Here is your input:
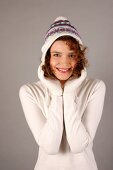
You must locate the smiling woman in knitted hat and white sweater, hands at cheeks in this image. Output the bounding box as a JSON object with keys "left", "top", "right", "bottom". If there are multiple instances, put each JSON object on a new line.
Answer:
{"left": 19, "top": 17, "right": 105, "bottom": 170}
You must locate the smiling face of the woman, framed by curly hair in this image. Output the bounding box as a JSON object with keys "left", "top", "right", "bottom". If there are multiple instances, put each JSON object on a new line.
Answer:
{"left": 50, "top": 40, "right": 77, "bottom": 84}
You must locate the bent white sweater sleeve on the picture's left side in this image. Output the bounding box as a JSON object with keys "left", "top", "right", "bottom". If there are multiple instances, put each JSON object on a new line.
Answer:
{"left": 19, "top": 85, "right": 63, "bottom": 154}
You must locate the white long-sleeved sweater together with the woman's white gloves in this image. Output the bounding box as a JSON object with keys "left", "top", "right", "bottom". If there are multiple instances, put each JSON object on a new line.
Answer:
{"left": 19, "top": 67, "right": 105, "bottom": 170}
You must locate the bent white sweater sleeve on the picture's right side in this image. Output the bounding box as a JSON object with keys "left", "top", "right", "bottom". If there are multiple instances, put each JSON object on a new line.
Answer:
{"left": 63, "top": 81, "right": 105, "bottom": 153}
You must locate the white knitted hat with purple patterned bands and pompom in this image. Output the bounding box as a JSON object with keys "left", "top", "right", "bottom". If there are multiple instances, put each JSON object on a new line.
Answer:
{"left": 41, "top": 16, "right": 83, "bottom": 64}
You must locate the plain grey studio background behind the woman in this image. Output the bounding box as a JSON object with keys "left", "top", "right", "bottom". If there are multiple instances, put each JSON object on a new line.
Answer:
{"left": 0, "top": 0, "right": 113, "bottom": 170}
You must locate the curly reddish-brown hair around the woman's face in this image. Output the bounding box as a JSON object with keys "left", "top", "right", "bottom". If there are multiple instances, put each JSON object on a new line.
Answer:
{"left": 42, "top": 36, "right": 89, "bottom": 79}
